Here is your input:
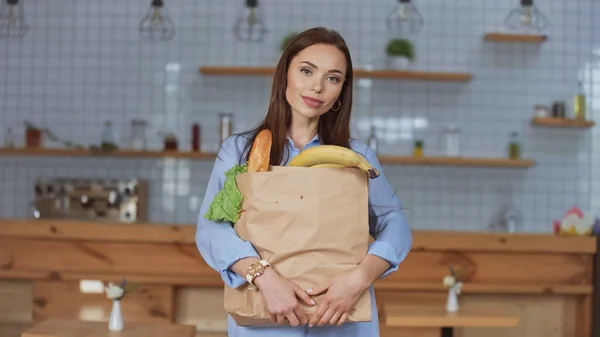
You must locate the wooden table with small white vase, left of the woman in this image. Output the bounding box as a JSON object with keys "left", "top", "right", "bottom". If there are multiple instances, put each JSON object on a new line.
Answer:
{"left": 21, "top": 319, "right": 196, "bottom": 337}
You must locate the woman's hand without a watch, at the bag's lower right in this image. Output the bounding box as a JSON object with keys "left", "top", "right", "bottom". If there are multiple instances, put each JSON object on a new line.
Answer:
{"left": 307, "top": 268, "right": 370, "bottom": 327}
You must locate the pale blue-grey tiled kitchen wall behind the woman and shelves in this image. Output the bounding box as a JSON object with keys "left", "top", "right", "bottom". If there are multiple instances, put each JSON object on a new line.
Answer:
{"left": 0, "top": 0, "right": 600, "bottom": 232}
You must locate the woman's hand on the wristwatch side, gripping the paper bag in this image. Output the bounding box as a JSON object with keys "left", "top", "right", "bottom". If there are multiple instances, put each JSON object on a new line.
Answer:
{"left": 254, "top": 268, "right": 315, "bottom": 326}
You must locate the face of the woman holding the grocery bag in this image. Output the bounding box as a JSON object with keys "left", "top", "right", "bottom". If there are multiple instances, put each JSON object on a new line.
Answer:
{"left": 285, "top": 44, "right": 346, "bottom": 119}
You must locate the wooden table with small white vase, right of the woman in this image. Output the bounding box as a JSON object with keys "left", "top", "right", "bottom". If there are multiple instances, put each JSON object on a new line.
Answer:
{"left": 384, "top": 305, "right": 519, "bottom": 337}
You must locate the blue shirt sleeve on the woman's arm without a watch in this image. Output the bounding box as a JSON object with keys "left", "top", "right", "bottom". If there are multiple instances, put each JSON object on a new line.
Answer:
{"left": 365, "top": 147, "right": 412, "bottom": 278}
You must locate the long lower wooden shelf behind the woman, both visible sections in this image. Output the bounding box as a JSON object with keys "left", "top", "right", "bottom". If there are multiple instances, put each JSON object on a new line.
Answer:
{"left": 0, "top": 148, "right": 535, "bottom": 168}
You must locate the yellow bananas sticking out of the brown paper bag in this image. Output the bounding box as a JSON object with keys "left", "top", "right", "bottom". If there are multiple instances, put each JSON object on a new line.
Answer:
{"left": 289, "top": 145, "right": 379, "bottom": 179}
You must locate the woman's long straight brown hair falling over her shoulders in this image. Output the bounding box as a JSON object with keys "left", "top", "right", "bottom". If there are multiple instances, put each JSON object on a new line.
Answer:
{"left": 240, "top": 27, "right": 354, "bottom": 165}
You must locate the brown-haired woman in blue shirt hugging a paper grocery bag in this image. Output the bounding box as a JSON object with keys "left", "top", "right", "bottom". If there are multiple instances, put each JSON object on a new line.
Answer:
{"left": 196, "top": 28, "right": 412, "bottom": 337}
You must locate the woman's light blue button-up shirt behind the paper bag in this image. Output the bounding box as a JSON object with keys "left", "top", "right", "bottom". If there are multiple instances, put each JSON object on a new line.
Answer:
{"left": 196, "top": 136, "right": 412, "bottom": 337}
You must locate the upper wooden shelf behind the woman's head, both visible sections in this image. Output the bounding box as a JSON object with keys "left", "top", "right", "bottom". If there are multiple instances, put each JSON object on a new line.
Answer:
{"left": 200, "top": 66, "right": 473, "bottom": 82}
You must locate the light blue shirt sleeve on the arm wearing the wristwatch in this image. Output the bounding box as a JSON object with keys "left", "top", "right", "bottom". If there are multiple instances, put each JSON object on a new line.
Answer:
{"left": 196, "top": 137, "right": 259, "bottom": 288}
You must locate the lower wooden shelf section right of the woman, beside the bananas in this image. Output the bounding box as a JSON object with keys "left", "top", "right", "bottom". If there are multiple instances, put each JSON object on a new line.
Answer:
{"left": 379, "top": 156, "right": 535, "bottom": 168}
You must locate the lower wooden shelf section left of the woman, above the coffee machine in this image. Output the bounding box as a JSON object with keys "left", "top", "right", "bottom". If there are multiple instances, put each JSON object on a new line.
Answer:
{"left": 0, "top": 148, "right": 216, "bottom": 159}
